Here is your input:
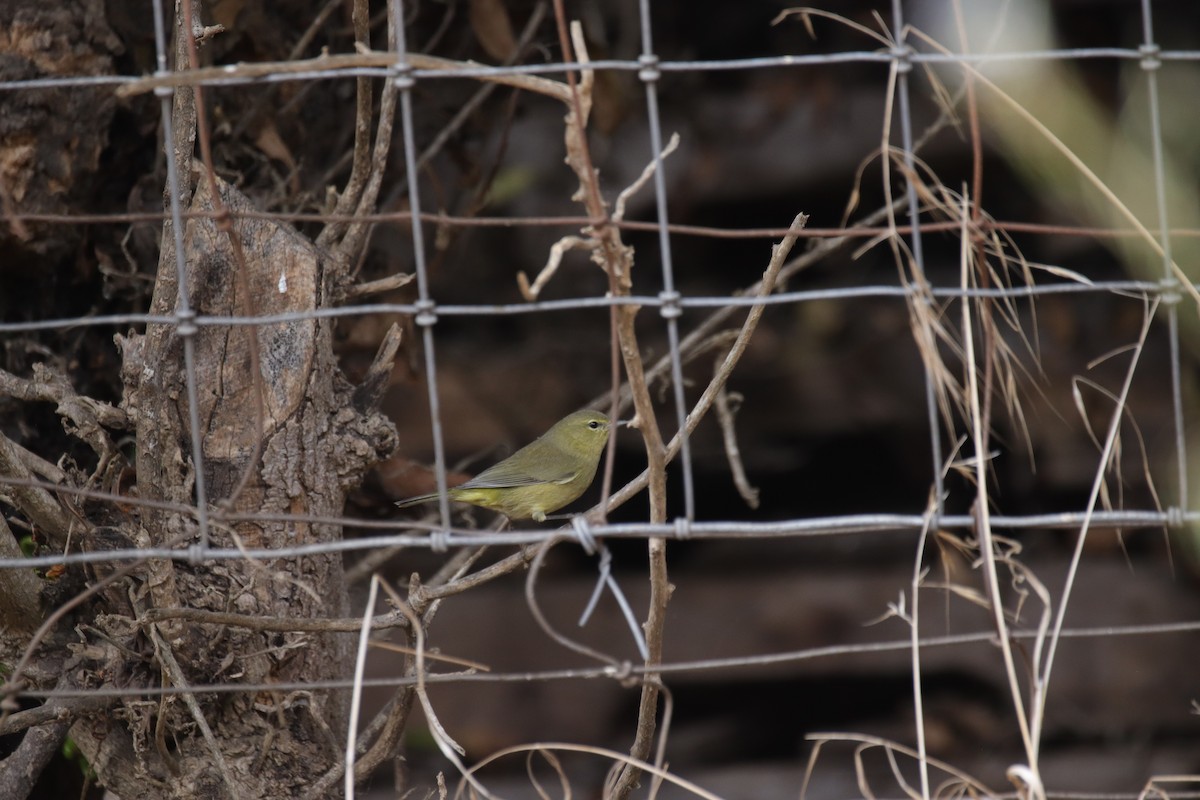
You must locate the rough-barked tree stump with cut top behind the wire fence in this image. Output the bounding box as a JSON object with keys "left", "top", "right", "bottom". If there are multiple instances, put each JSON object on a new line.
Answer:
{"left": 72, "top": 180, "right": 395, "bottom": 799}
